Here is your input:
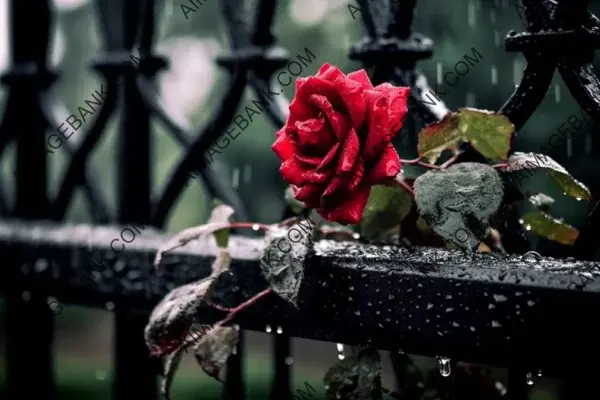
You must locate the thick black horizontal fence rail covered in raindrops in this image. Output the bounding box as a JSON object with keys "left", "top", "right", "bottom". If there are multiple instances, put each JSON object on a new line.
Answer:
{"left": 0, "top": 220, "right": 600, "bottom": 376}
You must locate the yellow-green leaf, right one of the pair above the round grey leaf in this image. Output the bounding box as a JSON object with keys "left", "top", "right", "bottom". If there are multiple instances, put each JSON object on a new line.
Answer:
{"left": 458, "top": 108, "right": 515, "bottom": 160}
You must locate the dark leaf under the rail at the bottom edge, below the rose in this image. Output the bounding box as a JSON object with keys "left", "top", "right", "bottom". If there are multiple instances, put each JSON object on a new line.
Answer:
{"left": 323, "top": 349, "right": 382, "bottom": 400}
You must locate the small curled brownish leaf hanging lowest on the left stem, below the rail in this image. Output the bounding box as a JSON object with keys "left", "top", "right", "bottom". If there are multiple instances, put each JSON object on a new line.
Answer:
{"left": 194, "top": 326, "right": 239, "bottom": 381}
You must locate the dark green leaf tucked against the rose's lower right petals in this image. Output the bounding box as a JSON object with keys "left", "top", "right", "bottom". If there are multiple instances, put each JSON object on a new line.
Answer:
{"left": 360, "top": 185, "right": 412, "bottom": 240}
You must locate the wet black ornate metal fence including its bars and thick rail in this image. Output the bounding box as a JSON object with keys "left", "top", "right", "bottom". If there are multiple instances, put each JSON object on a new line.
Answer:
{"left": 0, "top": 0, "right": 600, "bottom": 400}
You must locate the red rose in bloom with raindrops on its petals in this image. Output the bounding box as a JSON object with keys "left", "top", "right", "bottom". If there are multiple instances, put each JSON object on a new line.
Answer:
{"left": 272, "top": 63, "right": 410, "bottom": 224}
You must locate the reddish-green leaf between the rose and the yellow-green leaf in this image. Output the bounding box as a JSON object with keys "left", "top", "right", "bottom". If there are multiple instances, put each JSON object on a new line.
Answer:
{"left": 417, "top": 112, "right": 460, "bottom": 164}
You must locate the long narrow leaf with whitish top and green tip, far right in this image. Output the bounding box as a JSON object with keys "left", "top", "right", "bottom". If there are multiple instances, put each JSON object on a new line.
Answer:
{"left": 503, "top": 152, "right": 592, "bottom": 200}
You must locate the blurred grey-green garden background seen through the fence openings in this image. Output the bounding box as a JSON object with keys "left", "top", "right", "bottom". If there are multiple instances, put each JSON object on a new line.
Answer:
{"left": 0, "top": 0, "right": 600, "bottom": 400}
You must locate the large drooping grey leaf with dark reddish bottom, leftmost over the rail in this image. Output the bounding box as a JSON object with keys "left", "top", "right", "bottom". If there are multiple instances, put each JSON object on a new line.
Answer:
{"left": 144, "top": 251, "right": 231, "bottom": 355}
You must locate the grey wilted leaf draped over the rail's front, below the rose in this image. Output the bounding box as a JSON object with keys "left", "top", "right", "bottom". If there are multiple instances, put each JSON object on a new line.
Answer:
{"left": 260, "top": 218, "right": 312, "bottom": 306}
